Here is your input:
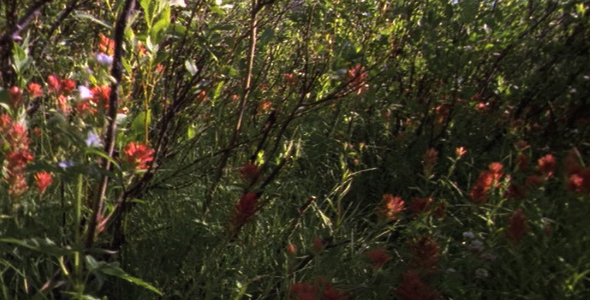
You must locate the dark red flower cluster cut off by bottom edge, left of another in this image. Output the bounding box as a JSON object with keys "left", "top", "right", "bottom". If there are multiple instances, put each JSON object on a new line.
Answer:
{"left": 289, "top": 278, "right": 348, "bottom": 300}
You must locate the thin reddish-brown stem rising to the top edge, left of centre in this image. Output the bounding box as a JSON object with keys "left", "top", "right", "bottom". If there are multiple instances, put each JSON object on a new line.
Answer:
{"left": 203, "top": 0, "right": 259, "bottom": 213}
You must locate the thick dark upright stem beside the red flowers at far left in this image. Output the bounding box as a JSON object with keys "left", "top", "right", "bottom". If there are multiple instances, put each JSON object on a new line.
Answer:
{"left": 85, "top": 0, "right": 135, "bottom": 248}
